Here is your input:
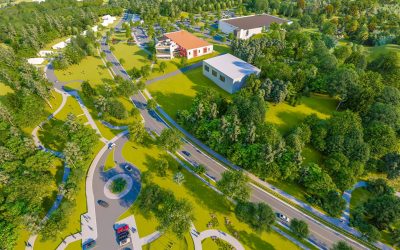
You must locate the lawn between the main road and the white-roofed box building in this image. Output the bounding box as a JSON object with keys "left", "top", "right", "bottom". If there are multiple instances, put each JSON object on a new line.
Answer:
{"left": 147, "top": 67, "right": 229, "bottom": 118}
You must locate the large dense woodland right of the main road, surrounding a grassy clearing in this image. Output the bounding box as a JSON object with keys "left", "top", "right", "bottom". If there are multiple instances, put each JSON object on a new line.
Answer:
{"left": 177, "top": 26, "right": 400, "bottom": 242}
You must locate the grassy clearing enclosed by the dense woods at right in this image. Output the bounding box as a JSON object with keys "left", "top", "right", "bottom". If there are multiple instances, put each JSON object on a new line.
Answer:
{"left": 265, "top": 94, "right": 337, "bottom": 133}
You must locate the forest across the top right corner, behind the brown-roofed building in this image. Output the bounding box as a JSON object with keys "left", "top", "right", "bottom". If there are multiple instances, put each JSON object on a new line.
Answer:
{"left": 243, "top": 0, "right": 400, "bottom": 45}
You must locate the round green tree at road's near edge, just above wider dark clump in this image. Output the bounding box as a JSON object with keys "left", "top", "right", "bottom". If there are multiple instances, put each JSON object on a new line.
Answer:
{"left": 217, "top": 170, "right": 250, "bottom": 201}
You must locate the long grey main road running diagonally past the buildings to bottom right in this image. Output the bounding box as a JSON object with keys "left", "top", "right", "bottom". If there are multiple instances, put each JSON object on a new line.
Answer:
{"left": 101, "top": 38, "right": 374, "bottom": 249}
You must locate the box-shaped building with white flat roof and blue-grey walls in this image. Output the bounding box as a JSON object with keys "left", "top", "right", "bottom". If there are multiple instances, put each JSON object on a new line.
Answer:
{"left": 203, "top": 54, "right": 261, "bottom": 94}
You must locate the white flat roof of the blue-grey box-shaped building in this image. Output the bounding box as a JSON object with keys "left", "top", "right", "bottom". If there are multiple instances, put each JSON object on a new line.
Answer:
{"left": 204, "top": 54, "right": 261, "bottom": 79}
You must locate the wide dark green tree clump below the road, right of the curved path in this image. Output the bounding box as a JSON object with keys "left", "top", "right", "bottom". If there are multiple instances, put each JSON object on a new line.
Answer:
{"left": 235, "top": 202, "right": 276, "bottom": 231}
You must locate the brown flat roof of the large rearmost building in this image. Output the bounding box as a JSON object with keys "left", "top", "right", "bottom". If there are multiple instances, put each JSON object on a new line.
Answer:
{"left": 221, "top": 14, "right": 291, "bottom": 30}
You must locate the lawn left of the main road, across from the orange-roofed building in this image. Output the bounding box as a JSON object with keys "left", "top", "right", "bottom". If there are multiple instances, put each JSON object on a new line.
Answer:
{"left": 55, "top": 56, "right": 112, "bottom": 85}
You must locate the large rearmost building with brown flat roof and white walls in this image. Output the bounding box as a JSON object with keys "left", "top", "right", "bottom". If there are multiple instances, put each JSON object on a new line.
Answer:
{"left": 218, "top": 14, "right": 292, "bottom": 39}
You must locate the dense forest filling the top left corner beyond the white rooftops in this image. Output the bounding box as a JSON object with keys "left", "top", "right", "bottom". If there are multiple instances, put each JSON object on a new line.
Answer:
{"left": 0, "top": 0, "right": 122, "bottom": 57}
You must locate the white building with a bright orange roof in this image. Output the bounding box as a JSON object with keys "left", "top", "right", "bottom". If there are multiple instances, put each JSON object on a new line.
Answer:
{"left": 156, "top": 30, "right": 213, "bottom": 59}
